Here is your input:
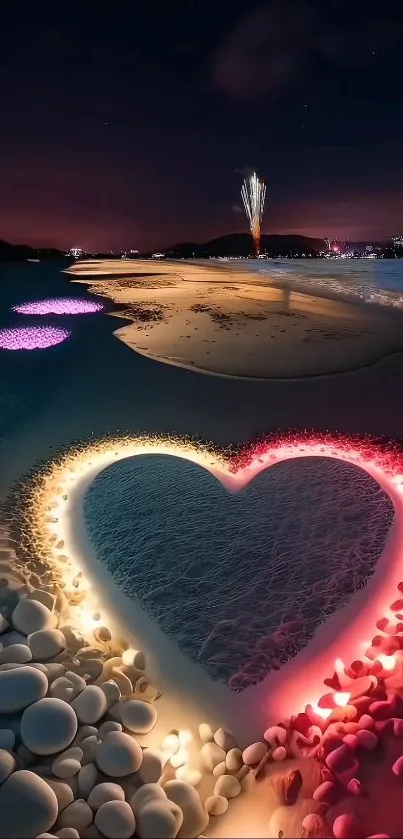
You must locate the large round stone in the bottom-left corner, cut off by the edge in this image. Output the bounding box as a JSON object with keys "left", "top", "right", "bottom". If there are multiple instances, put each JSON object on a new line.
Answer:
{"left": 0, "top": 769, "right": 58, "bottom": 839}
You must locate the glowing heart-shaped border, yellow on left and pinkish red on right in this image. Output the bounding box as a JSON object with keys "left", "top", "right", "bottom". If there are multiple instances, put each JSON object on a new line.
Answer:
{"left": 27, "top": 434, "right": 403, "bottom": 739}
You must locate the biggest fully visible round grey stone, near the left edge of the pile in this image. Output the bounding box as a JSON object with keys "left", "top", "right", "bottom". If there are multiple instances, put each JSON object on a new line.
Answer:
{"left": 21, "top": 700, "right": 77, "bottom": 755}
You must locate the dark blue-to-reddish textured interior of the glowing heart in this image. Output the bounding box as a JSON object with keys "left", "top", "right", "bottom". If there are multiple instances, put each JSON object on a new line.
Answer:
{"left": 84, "top": 449, "right": 393, "bottom": 691}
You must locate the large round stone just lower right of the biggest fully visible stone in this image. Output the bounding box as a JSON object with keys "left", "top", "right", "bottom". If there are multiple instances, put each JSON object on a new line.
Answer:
{"left": 95, "top": 731, "right": 143, "bottom": 778}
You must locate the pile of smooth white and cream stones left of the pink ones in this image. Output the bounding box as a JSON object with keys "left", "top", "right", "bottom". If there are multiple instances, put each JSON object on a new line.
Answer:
{"left": 0, "top": 585, "right": 248, "bottom": 839}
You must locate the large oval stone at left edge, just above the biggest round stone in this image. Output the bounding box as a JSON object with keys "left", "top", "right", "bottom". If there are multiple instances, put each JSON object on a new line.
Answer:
{"left": 0, "top": 666, "right": 48, "bottom": 714}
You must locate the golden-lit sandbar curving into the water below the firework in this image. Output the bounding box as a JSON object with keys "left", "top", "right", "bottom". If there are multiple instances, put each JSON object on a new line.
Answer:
{"left": 69, "top": 260, "right": 403, "bottom": 379}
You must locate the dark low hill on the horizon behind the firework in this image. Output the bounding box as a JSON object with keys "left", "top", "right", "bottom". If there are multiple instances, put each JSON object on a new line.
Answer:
{"left": 159, "top": 233, "right": 325, "bottom": 259}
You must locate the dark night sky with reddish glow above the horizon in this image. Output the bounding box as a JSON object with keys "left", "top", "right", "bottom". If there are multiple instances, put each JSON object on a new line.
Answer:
{"left": 0, "top": 0, "right": 403, "bottom": 250}
